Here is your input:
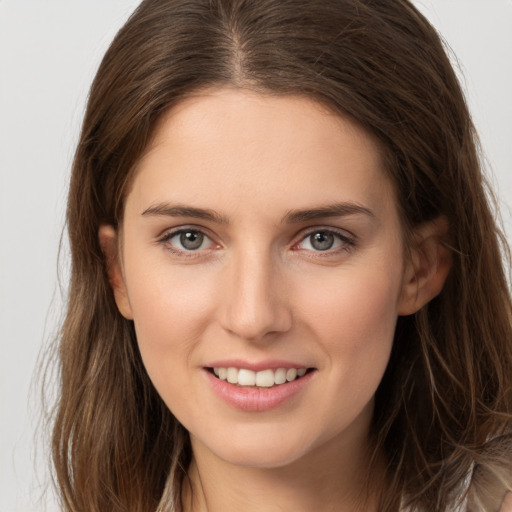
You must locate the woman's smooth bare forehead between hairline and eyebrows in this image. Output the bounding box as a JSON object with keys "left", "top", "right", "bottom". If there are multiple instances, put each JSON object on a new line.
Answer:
{"left": 128, "top": 88, "right": 394, "bottom": 222}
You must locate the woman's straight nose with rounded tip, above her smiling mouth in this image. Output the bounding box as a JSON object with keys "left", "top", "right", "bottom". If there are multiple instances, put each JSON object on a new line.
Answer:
{"left": 219, "top": 247, "right": 292, "bottom": 341}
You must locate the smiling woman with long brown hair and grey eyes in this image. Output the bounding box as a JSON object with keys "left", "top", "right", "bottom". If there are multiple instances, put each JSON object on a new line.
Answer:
{"left": 53, "top": 0, "right": 512, "bottom": 512}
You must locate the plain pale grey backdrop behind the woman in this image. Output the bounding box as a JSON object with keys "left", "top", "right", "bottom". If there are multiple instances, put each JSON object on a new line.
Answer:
{"left": 0, "top": 0, "right": 512, "bottom": 512}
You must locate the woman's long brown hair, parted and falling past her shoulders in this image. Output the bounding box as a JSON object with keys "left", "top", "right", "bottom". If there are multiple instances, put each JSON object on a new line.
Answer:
{"left": 53, "top": 0, "right": 512, "bottom": 512}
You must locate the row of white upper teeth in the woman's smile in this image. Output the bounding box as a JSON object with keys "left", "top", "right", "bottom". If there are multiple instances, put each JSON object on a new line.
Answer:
{"left": 213, "top": 367, "right": 307, "bottom": 388}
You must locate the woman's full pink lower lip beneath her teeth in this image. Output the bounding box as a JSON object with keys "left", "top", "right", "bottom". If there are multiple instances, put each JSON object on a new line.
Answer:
{"left": 204, "top": 368, "right": 316, "bottom": 412}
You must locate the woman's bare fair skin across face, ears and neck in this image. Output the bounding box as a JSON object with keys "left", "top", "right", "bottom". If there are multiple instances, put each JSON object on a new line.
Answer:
{"left": 100, "top": 88, "right": 450, "bottom": 512}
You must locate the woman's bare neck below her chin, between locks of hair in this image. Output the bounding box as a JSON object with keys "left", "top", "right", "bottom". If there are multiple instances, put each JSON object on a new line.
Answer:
{"left": 183, "top": 430, "right": 384, "bottom": 512}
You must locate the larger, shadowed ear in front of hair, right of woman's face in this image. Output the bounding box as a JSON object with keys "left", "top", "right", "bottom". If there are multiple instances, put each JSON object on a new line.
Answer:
{"left": 398, "top": 217, "right": 452, "bottom": 315}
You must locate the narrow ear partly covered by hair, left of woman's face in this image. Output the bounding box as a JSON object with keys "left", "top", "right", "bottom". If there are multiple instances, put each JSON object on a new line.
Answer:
{"left": 98, "top": 225, "right": 133, "bottom": 320}
